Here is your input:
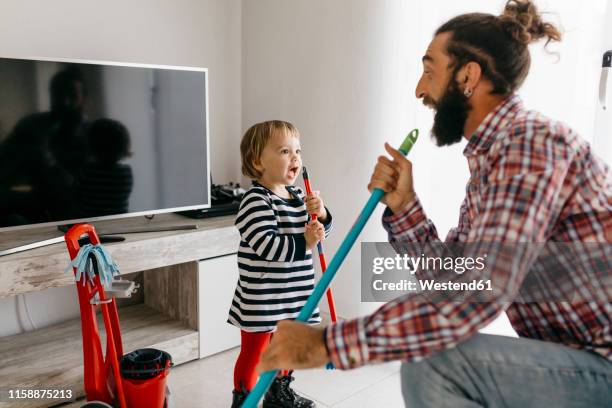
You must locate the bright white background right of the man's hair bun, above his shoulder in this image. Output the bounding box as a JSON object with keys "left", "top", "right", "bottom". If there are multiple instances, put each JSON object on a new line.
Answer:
{"left": 521, "top": 0, "right": 607, "bottom": 147}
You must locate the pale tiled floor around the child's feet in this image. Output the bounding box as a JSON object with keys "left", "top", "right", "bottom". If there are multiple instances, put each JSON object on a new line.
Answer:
{"left": 168, "top": 348, "right": 404, "bottom": 408}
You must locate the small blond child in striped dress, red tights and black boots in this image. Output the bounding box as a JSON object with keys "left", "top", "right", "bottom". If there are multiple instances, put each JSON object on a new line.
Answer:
{"left": 228, "top": 121, "right": 331, "bottom": 408}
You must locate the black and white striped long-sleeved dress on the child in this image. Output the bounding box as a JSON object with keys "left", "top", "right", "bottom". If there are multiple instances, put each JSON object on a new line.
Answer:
{"left": 228, "top": 182, "right": 331, "bottom": 332}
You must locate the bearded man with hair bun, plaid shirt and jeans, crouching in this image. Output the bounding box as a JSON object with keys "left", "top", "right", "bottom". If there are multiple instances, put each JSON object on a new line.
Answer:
{"left": 259, "top": 1, "right": 612, "bottom": 407}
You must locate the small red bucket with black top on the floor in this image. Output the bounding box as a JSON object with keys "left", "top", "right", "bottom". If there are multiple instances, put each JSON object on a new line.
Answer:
{"left": 121, "top": 349, "right": 172, "bottom": 408}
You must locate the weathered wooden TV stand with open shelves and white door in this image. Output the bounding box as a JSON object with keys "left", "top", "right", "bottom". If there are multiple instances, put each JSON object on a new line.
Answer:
{"left": 0, "top": 214, "right": 240, "bottom": 408}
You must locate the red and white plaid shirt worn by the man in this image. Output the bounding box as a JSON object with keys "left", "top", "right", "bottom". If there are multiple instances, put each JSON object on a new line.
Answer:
{"left": 324, "top": 95, "right": 612, "bottom": 369}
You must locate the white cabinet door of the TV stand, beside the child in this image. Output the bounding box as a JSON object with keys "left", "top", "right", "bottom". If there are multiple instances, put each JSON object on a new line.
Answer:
{"left": 198, "top": 255, "right": 240, "bottom": 358}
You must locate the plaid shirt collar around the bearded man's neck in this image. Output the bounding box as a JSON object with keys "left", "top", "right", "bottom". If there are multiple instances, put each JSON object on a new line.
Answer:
{"left": 463, "top": 94, "right": 523, "bottom": 157}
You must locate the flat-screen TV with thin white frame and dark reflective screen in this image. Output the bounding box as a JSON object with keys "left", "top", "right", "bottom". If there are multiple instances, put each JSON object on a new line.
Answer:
{"left": 0, "top": 58, "right": 210, "bottom": 231}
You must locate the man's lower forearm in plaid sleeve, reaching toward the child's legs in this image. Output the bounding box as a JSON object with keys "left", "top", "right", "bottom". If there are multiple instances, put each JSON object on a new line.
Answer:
{"left": 325, "top": 296, "right": 503, "bottom": 370}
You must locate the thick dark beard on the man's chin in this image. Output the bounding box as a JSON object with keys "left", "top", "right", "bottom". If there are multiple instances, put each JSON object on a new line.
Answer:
{"left": 423, "top": 79, "right": 472, "bottom": 146}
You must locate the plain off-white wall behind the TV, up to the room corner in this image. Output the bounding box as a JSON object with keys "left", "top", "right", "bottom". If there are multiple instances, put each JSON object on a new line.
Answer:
{"left": 0, "top": 0, "right": 242, "bottom": 336}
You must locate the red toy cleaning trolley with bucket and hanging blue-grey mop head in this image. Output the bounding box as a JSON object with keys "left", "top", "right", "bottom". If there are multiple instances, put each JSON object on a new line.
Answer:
{"left": 64, "top": 224, "right": 172, "bottom": 408}
